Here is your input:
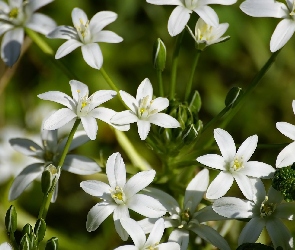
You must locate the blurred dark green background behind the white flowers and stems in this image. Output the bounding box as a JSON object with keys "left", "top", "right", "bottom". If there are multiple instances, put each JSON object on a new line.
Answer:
{"left": 0, "top": 0, "right": 295, "bottom": 249}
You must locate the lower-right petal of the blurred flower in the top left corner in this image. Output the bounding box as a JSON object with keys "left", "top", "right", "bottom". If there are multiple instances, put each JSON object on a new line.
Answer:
{"left": 26, "top": 13, "right": 56, "bottom": 35}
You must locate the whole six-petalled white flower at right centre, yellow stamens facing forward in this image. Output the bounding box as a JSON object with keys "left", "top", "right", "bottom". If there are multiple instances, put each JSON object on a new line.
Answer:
{"left": 197, "top": 128, "right": 275, "bottom": 200}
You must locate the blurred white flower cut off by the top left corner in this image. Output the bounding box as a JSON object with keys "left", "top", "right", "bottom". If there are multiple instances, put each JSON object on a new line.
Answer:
{"left": 0, "top": 0, "right": 56, "bottom": 67}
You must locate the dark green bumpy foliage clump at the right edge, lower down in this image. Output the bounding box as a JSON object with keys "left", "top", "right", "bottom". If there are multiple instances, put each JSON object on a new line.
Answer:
{"left": 272, "top": 164, "right": 295, "bottom": 202}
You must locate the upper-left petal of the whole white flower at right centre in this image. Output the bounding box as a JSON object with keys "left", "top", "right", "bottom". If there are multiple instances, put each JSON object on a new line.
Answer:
{"left": 214, "top": 128, "right": 236, "bottom": 162}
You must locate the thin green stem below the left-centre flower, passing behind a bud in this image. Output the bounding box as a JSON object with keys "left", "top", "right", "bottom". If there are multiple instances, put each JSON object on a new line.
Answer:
{"left": 38, "top": 119, "right": 81, "bottom": 220}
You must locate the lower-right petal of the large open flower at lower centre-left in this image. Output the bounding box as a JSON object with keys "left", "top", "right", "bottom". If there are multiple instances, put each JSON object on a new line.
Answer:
{"left": 127, "top": 194, "right": 166, "bottom": 218}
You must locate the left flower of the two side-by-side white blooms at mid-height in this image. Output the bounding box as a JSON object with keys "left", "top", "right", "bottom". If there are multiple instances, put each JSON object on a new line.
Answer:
{"left": 38, "top": 80, "right": 129, "bottom": 140}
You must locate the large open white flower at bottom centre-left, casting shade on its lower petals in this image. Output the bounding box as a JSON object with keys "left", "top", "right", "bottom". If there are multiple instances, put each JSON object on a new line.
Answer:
{"left": 80, "top": 153, "right": 166, "bottom": 240}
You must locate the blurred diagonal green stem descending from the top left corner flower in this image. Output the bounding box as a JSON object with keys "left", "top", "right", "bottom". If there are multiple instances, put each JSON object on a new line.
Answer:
{"left": 25, "top": 28, "right": 79, "bottom": 80}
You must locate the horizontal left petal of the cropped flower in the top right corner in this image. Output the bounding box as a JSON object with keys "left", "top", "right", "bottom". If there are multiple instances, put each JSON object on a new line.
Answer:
{"left": 240, "top": 0, "right": 288, "bottom": 18}
